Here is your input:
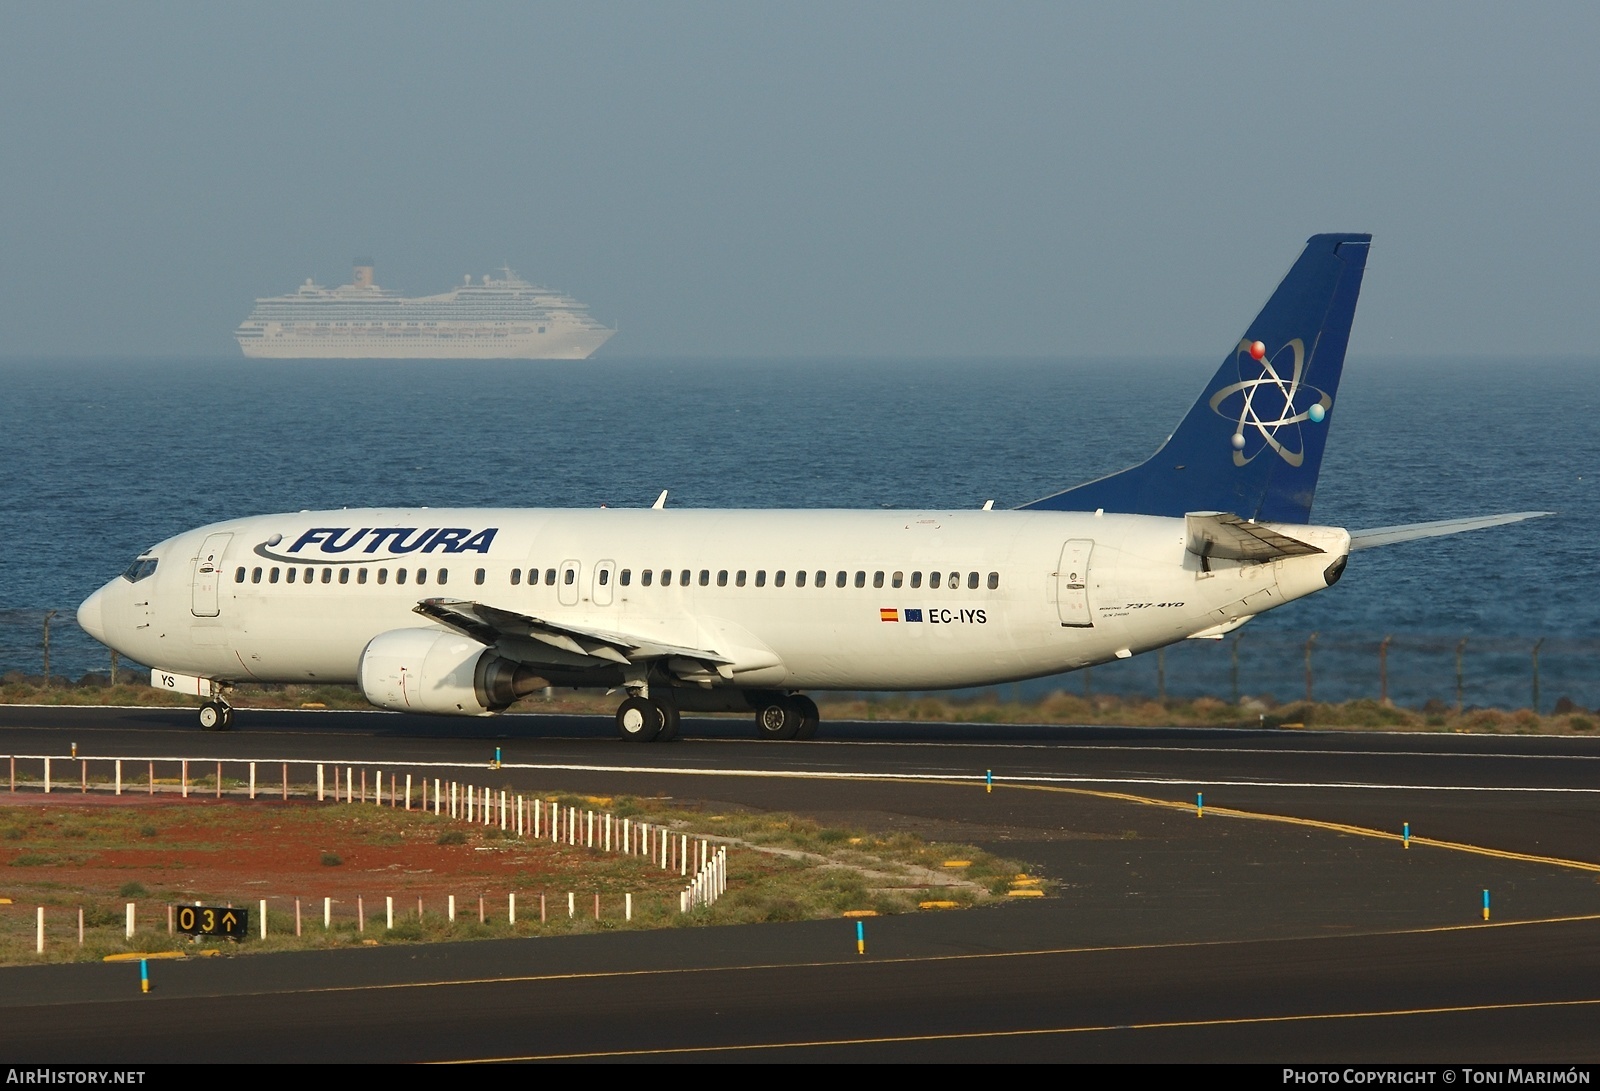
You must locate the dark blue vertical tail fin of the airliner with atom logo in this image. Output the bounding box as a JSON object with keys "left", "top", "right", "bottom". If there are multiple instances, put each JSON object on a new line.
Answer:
{"left": 1022, "top": 235, "right": 1373, "bottom": 523}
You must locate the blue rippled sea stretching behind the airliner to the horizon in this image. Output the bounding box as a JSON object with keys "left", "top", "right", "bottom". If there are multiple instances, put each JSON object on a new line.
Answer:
{"left": 0, "top": 358, "right": 1600, "bottom": 709}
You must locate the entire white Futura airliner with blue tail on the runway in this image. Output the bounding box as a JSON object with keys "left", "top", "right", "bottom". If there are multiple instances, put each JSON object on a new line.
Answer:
{"left": 78, "top": 235, "right": 1542, "bottom": 742}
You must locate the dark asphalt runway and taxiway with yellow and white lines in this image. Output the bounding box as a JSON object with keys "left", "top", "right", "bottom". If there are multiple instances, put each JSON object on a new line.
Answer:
{"left": 0, "top": 707, "right": 1600, "bottom": 1064}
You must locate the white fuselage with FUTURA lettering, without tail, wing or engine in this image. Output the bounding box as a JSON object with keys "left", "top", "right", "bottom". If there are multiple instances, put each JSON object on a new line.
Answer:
{"left": 80, "top": 509, "right": 1349, "bottom": 689}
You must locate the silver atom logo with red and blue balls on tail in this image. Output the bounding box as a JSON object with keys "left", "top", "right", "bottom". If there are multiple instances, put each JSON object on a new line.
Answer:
{"left": 1210, "top": 338, "right": 1333, "bottom": 466}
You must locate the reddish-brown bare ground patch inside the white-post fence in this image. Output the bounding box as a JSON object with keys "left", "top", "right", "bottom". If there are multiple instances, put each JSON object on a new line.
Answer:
{"left": 0, "top": 792, "right": 700, "bottom": 912}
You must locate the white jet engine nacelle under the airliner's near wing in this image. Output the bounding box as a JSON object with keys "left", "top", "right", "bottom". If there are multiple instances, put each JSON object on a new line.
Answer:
{"left": 355, "top": 629, "right": 544, "bottom": 717}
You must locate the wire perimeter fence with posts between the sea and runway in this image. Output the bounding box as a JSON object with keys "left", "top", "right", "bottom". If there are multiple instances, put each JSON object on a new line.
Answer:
{"left": 0, "top": 609, "right": 1600, "bottom": 713}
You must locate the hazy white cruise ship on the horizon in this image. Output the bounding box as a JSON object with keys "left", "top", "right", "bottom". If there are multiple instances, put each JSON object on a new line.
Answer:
{"left": 234, "top": 259, "right": 616, "bottom": 360}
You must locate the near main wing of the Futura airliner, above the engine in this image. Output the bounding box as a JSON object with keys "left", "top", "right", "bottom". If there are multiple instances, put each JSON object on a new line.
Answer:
{"left": 413, "top": 598, "right": 742, "bottom": 680}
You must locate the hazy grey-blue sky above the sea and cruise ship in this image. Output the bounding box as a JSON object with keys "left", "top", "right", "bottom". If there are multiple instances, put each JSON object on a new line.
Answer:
{"left": 0, "top": 0, "right": 1600, "bottom": 357}
